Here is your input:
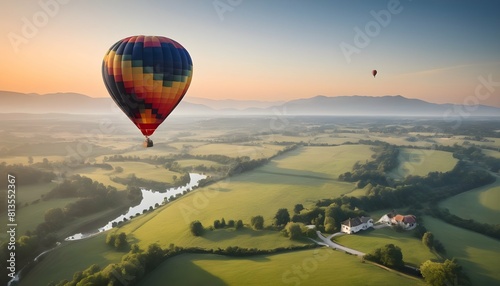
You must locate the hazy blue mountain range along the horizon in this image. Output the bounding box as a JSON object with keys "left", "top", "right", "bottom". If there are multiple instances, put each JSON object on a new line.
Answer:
{"left": 0, "top": 91, "right": 500, "bottom": 117}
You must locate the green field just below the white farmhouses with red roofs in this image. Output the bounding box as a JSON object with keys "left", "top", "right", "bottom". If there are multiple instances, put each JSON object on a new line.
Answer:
{"left": 334, "top": 227, "right": 438, "bottom": 267}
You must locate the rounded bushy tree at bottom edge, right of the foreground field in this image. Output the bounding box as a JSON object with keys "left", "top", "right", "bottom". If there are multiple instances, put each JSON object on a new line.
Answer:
{"left": 420, "top": 259, "right": 462, "bottom": 286}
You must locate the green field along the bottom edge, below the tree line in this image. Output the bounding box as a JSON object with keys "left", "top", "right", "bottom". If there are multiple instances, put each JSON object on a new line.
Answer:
{"left": 139, "top": 248, "right": 425, "bottom": 286}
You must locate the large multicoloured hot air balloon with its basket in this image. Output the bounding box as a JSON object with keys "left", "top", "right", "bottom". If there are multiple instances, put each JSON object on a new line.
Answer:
{"left": 102, "top": 36, "right": 193, "bottom": 147}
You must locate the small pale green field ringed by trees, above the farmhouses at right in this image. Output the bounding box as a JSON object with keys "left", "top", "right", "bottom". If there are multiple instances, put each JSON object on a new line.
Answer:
{"left": 388, "top": 148, "right": 458, "bottom": 179}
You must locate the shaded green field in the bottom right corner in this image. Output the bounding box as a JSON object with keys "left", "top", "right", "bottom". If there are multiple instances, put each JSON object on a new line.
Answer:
{"left": 424, "top": 216, "right": 500, "bottom": 285}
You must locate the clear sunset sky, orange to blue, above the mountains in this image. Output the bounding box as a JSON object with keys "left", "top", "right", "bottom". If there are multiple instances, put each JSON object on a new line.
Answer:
{"left": 0, "top": 0, "right": 500, "bottom": 107}
